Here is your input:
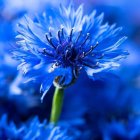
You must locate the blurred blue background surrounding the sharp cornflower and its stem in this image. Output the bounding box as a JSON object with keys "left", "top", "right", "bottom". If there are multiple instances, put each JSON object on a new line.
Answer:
{"left": 0, "top": 0, "right": 140, "bottom": 140}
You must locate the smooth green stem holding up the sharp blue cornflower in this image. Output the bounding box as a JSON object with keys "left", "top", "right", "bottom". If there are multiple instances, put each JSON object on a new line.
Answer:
{"left": 50, "top": 88, "right": 64, "bottom": 124}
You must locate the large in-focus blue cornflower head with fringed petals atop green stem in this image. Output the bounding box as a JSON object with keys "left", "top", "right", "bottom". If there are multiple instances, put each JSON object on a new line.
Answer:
{"left": 14, "top": 4, "right": 127, "bottom": 98}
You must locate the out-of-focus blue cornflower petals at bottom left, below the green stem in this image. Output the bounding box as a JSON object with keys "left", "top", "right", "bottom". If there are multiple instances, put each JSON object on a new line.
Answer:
{"left": 0, "top": 115, "right": 87, "bottom": 140}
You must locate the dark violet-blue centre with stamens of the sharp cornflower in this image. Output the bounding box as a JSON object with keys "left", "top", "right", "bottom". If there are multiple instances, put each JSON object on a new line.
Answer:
{"left": 42, "top": 28, "right": 98, "bottom": 68}
